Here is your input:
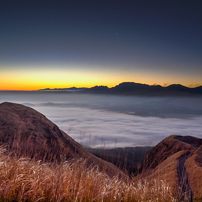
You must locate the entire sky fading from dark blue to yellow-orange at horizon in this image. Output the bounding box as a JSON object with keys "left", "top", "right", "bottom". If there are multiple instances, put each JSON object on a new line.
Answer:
{"left": 0, "top": 0, "right": 202, "bottom": 90}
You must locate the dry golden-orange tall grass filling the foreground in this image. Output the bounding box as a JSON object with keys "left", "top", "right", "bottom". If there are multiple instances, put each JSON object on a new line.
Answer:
{"left": 0, "top": 148, "right": 173, "bottom": 202}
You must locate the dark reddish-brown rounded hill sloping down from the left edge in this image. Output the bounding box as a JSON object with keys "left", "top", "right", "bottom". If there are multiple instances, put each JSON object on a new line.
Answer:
{"left": 0, "top": 102, "right": 122, "bottom": 176}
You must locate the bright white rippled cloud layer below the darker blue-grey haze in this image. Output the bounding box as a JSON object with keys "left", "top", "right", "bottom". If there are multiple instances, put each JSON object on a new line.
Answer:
{"left": 35, "top": 107, "right": 202, "bottom": 147}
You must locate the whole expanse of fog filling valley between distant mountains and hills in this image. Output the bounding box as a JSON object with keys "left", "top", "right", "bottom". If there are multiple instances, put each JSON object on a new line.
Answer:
{"left": 0, "top": 92, "right": 202, "bottom": 147}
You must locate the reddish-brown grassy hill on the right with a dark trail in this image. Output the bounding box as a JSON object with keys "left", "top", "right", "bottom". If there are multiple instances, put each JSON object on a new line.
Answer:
{"left": 136, "top": 135, "right": 202, "bottom": 201}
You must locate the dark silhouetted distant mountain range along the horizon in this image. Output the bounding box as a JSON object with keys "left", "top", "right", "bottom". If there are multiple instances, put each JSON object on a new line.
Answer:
{"left": 40, "top": 82, "right": 202, "bottom": 96}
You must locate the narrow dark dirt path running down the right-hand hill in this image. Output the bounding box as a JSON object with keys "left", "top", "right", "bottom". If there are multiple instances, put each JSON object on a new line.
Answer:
{"left": 178, "top": 154, "right": 193, "bottom": 201}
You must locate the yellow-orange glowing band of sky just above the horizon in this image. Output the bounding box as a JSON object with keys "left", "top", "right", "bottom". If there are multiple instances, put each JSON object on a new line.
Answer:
{"left": 0, "top": 68, "right": 202, "bottom": 91}
